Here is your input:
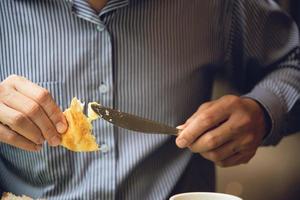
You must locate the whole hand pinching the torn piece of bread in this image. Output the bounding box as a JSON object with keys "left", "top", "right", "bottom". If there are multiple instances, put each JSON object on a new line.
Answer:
{"left": 0, "top": 75, "right": 68, "bottom": 151}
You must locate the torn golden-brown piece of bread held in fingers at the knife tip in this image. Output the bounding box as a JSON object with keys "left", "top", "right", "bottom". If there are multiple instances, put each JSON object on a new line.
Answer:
{"left": 61, "top": 97, "right": 99, "bottom": 152}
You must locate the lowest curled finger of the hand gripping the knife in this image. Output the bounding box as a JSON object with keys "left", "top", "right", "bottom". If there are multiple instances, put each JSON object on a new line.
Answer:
{"left": 215, "top": 151, "right": 255, "bottom": 167}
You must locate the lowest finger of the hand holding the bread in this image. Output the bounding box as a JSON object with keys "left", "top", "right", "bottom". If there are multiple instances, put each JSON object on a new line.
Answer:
{"left": 0, "top": 124, "right": 42, "bottom": 151}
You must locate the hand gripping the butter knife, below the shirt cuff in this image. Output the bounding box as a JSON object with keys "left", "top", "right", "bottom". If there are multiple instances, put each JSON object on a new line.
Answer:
{"left": 176, "top": 95, "right": 266, "bottom": 167}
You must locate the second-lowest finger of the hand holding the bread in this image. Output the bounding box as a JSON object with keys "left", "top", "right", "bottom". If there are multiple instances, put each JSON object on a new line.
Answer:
{"left": 0, "top": 104, "right": 44, "bottom": 144}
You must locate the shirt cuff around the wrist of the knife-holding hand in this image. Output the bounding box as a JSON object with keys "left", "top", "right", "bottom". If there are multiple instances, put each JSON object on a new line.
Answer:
{"left": 243, "top": 86, "right": 286, "bottom": 146}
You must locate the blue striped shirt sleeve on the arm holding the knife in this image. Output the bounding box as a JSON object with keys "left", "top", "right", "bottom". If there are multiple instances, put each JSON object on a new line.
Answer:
{"left": 225, "top": 0, "right": 300, "bottom": 145}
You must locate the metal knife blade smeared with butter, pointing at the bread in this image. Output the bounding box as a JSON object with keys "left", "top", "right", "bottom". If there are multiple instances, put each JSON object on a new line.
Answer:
{"left": 91, "top": 104, "right": 180, "bottom": 135}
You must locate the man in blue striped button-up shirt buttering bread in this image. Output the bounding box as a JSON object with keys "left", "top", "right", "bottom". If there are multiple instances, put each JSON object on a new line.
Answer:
{"left": 0, "top": 0, "right": 300, "bottom": 200}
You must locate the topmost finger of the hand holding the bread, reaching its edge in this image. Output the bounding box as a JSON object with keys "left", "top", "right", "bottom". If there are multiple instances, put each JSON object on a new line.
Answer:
{"left": 6, "top": 76, "right": 67, "bottom": 133}
